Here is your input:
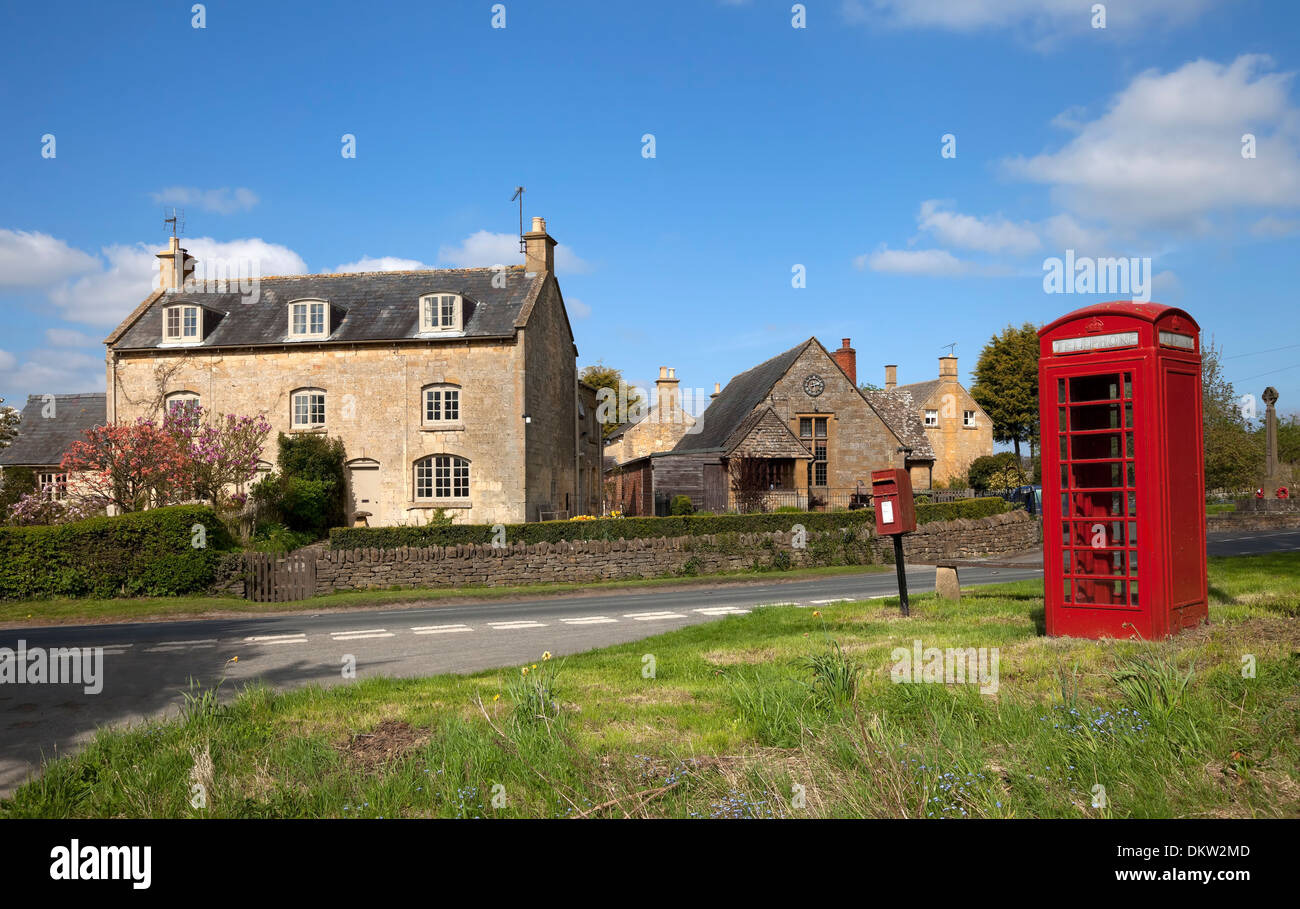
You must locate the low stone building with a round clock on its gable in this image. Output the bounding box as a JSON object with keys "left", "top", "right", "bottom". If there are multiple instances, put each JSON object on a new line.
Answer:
{"left": 611, "top": 338, "right": 933, "bottom": 514}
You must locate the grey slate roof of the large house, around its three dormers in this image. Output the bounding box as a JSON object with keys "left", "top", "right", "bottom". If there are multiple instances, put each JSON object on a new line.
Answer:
{"left": 105, "top": 265, "right": 546, "bottom": 350}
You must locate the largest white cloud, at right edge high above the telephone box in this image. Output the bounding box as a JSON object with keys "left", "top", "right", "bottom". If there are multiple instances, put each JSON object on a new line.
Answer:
{"left": 1004, "top": 55, "right": 1300, "bottom": 231}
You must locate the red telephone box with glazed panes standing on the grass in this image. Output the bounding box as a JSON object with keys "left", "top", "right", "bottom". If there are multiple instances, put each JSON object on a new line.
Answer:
{"left": 1039, "top": 302, "right": 1209, "bottom": 639}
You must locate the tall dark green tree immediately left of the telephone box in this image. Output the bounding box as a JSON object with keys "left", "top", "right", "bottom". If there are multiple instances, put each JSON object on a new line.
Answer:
{"left": 971, "top": 323, "right": 1039, "bottom": 458}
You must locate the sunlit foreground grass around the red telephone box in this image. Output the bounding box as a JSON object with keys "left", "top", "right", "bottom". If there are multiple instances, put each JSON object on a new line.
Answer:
{"left": 0, "top": 554, "right": 1300, "bottom": 818}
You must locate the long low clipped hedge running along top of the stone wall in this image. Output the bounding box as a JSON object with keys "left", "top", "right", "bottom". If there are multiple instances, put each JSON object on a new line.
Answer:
{"left": 329, "top": 498, "right": 1010, "bottom": 549}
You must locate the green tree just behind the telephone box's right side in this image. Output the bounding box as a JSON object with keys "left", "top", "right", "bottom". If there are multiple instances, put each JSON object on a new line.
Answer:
{"left": 1201, "top": 339, "right": 1264, "bottom": 489}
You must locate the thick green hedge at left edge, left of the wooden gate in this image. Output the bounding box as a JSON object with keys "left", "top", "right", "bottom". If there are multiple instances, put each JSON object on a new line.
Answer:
{"left": 0, "top": 505, "right": 235, "bottom": 599}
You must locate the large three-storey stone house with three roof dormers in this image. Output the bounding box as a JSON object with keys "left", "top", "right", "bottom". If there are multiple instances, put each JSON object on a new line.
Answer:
{"left": 105, "top": 218, "right": 601, "bottom": 525}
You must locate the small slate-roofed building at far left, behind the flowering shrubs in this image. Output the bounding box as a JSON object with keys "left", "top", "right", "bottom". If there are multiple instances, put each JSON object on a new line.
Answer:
{"left": 0, "top": 393, "right": 107, "bottom": 501}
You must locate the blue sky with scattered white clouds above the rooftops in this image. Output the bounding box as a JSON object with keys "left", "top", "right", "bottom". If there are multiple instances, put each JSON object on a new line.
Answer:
{"left": 0, "top": 0, "right": 1300, "bottom": 423}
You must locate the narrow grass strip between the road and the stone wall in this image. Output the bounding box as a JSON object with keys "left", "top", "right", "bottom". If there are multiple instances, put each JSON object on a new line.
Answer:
{"left": 0, "top": 564, "right": 893, "bottom": 628}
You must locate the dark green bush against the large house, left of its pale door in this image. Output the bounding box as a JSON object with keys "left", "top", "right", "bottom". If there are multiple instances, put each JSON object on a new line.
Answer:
{"left": 254, "top": 433, "right": 347, "bottom": 540}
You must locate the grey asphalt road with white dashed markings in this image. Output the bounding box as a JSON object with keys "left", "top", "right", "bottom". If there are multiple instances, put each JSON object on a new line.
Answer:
{"left": 0, "top": 531, "right": 1300, "bottom": 793}
